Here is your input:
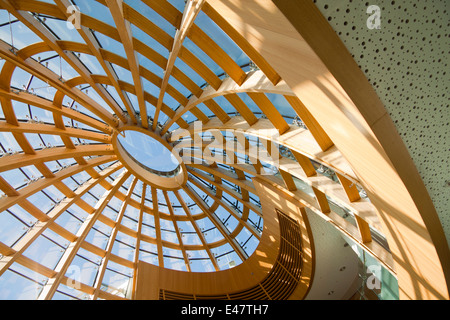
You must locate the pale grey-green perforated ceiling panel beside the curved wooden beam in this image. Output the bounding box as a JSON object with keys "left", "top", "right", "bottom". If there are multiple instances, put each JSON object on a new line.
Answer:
{"left": 314, "top": 0, "right": 450, "bottom": 242}
